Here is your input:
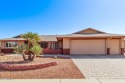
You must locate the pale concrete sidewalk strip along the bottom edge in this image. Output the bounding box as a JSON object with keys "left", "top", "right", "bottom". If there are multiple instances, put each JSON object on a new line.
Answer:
{"left": 0, "top": 79, "right": 125, "bottom": 83}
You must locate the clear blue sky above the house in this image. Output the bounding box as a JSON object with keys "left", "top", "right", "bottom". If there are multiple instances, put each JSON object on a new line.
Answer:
{"left": 0, "top": 0, "right": 125, "bottom": 38}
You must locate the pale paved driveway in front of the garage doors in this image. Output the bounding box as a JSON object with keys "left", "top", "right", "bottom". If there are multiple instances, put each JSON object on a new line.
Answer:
{"left": 72, "top": 55, "right": 125, "bottom": 79}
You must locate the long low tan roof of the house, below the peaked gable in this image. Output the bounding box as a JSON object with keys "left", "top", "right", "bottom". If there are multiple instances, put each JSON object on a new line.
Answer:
{"left": 0, "top": 33, "right": 125, "bottom": 41}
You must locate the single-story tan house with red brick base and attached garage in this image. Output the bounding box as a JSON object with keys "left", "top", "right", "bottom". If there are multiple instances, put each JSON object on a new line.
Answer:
{"left": 0, "top": 28, "right": 125, "bottom": 55}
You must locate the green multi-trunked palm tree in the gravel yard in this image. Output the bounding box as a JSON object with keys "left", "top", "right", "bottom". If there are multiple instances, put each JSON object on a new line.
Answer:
{"left": 15, "top": 32, "right": 42, "bottom": 61}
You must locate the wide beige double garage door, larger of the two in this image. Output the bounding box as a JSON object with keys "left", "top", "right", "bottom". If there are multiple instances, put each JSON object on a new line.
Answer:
{"left": 70, "top": 40, "right": 106, "bottom": 54}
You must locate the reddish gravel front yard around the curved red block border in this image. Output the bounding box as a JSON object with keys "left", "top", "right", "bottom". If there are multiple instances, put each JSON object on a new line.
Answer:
{"left": 0, "top": 56, "right": 84, "bottom": 79}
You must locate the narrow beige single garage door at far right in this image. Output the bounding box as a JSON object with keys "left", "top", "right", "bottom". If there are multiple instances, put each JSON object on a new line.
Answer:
{"left": 110, "top": 39, "right": 120, "bottom": 54}
